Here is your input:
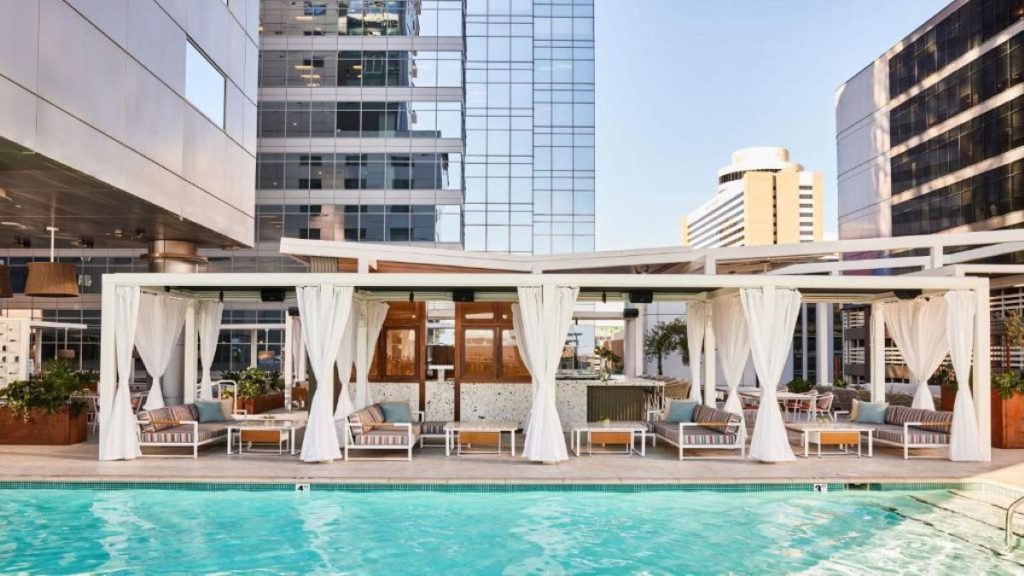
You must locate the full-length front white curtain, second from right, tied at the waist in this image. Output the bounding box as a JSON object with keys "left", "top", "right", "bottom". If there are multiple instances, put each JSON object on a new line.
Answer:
{"left": 739, "top": 286, "right": 800, "bottom": 462}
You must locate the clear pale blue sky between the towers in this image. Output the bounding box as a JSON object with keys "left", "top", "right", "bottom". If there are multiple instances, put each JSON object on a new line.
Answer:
{"left": 594, "top": 0, "right": 948, "bottom": 250}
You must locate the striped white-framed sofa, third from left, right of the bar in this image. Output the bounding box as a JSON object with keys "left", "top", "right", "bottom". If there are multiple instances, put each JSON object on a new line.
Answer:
{"left": 650, "top": 404, "right": 746, "bottom": 460}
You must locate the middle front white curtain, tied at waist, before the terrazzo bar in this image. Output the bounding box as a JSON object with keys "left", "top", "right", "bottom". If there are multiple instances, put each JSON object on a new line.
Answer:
{"left": 512, "top": 286, "right": 580, "bottom": 462}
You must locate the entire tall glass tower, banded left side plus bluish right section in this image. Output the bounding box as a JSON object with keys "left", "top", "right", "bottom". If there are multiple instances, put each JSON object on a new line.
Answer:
{"left": 251, "top": 0, "right": 594, "bottom": 255}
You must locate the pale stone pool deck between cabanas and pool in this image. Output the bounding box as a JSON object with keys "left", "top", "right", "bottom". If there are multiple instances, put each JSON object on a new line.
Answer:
{"left": 0, "top": 434, "right": 1024, "bottom": 490}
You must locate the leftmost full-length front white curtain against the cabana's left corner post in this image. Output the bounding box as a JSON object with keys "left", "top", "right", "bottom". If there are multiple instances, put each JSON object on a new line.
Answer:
{"left": 99, "top": 286, "right": 141, "bottom": 460}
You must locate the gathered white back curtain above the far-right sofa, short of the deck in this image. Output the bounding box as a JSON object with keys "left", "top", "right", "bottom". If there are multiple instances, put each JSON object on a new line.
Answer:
{"left": 884, "top": 298, "right": 946, "bottom": 410}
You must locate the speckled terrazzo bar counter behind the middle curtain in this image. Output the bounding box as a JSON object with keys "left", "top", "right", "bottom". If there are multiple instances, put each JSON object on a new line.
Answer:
{"left": 362, "top": 378, "right": 665, "bottom": 431}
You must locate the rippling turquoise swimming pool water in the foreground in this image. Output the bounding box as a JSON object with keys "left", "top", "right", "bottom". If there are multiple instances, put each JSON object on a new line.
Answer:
{"left": 0, "top": 481, "right": 1024, "bottom": 576}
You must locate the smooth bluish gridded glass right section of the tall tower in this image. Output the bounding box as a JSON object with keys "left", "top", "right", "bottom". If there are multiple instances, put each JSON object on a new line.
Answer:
{"left": 465, "top": 0, "right": 595, "bottom": 254}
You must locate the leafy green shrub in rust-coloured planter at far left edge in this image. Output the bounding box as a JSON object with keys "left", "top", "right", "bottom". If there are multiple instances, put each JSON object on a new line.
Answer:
{"left": 0, "top": 360, "right": 88, "bottom": 445}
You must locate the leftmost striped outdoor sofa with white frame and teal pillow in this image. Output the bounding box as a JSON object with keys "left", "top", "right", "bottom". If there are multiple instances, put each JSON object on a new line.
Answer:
{"left": 136, "top": 404, "right": 244, "bottom": 458}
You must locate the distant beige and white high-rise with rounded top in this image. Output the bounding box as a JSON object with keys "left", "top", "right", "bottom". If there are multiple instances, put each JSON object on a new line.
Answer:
{"left": 682, "top": 148, "right": 823, "bottom": 248}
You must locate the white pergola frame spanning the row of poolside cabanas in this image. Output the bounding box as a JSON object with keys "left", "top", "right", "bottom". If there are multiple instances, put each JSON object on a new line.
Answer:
{"left": 99, "top": 266, "right": 995, "bottom": 459}
